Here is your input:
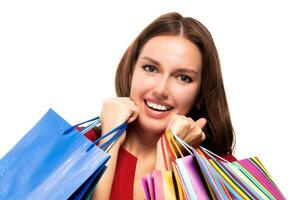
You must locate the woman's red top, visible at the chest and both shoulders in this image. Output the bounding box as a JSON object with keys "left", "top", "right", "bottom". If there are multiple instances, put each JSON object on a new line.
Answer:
{"left": 85, "top": 130, "right": 236, "bottom": 200}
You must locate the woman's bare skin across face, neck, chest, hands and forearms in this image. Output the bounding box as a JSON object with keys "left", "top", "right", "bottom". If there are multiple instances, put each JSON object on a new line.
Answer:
{"left": 93, "top": 36, "right": 206, "bottom": 199}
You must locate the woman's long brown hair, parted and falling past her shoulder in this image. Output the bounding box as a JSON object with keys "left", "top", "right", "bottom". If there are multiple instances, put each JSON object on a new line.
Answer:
{"left": 115, "top": 12, "right": 234, "bottom": 155}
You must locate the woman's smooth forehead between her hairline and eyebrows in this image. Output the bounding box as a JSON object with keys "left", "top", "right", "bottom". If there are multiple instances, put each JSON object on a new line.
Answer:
{"left": 139, "top": 36, "right": 202, "bottom": 71}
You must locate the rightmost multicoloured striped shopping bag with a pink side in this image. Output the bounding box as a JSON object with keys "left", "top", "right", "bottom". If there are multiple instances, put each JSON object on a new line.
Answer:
{"left": 197, "top": 147, "right": 285, "bottom": 200}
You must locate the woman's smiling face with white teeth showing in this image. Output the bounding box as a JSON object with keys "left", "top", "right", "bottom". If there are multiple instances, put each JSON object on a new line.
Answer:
{"left": 130, "top": 36, "right": 202, "bottom": 133}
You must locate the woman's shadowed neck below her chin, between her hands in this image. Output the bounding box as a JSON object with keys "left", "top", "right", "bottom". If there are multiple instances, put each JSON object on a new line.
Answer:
{"left": 123, "top": 122, "right": 161, "bottom": 157}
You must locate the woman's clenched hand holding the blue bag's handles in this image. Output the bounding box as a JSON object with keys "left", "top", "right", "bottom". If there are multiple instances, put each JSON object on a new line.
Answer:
{"left": 100, "top": 97, "right": 139, "bottom": 145}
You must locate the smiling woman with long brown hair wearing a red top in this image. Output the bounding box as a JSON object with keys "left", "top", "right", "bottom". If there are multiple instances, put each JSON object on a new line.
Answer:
{"left": 88, "top": 13, "right": 234, "bottom": 199}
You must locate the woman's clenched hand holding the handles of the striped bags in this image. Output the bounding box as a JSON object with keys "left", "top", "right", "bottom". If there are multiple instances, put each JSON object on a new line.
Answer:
{"left": 166, "top": 115, "right": 207, "bottom": 147}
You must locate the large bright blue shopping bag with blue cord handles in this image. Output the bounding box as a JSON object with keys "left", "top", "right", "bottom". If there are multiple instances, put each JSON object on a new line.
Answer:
{"left": 0, "top": 109, "right": 127, "bottom": 200}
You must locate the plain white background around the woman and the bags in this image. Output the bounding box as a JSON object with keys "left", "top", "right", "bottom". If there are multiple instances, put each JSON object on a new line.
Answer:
{"left": 0, "top": 0, "right": 300, "bottom": 199}
